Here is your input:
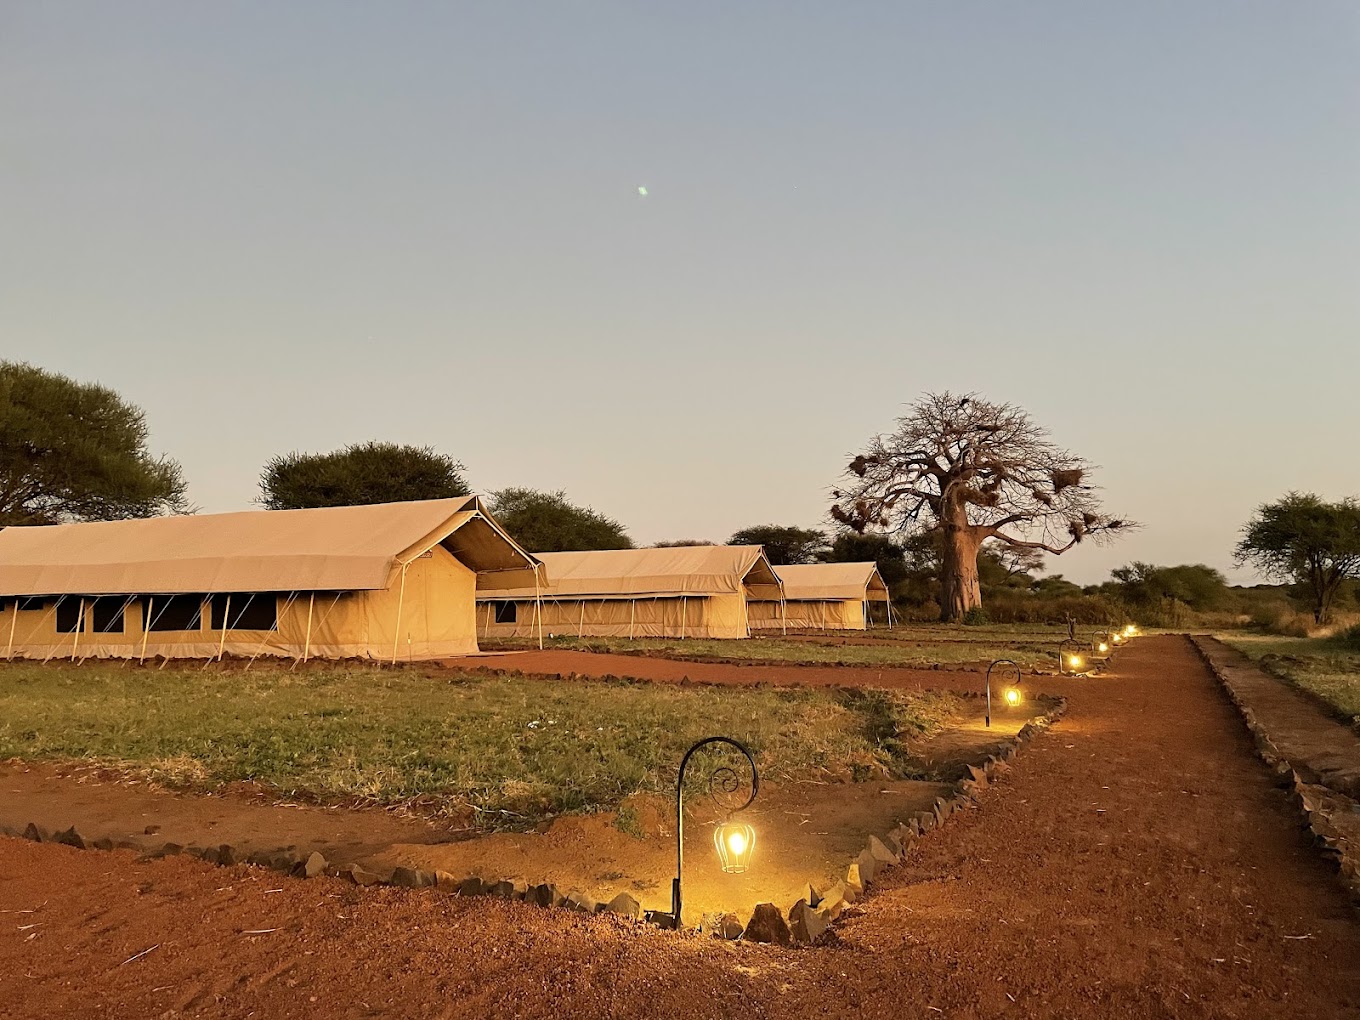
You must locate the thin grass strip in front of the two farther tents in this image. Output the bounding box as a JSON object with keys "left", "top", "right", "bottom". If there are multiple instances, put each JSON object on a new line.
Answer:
{"left": 481, "top": 624, "right": 1095, "bottom": 669}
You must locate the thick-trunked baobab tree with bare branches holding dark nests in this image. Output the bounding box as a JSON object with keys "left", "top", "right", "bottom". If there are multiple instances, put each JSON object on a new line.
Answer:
{"left": 831, "top": 392, "right": 1132, "bottom": 622}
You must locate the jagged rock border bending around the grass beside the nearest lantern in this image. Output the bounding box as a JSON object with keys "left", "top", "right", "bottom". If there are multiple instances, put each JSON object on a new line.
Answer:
{"left": 0, "top": 691, "right": 1068, "bottom": 945}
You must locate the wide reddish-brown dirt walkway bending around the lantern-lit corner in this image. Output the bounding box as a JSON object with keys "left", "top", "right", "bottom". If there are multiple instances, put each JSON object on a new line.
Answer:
{"left": 0, "top": 638, "right": 1360, "bottom": 1020}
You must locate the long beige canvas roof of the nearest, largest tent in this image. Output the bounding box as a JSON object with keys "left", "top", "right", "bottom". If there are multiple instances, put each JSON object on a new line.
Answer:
{"left": 0, "top": 496, "right": 537, "bottom": 596}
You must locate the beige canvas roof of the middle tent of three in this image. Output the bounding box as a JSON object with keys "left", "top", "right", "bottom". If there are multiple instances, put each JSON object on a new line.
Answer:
{"left": 477, "top": 545, "right": 781, "bottom": 598}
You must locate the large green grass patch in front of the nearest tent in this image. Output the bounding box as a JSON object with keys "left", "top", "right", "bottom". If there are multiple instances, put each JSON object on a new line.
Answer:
{"left": 0, "top": 662, "right": 960, "bottom": 828}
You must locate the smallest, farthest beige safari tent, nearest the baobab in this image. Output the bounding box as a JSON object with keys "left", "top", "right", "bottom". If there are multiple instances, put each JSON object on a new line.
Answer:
{"left": 749, "top": 562, "right": 892, "bottom": 631}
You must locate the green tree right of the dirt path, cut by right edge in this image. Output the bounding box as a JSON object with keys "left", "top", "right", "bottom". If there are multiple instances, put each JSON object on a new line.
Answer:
{"left": 1236, "top": 492, "right": 1360, "bottom": 624}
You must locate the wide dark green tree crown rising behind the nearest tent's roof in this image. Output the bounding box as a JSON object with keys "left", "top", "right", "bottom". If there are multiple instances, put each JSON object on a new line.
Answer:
{"left": 257, "top": 442, "right": 471, "bottom": 510}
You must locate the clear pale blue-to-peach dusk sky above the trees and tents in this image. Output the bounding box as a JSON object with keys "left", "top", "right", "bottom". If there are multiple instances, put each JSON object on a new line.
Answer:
{"left": 0, "top": 0, "right": 1360, "bottom": 582}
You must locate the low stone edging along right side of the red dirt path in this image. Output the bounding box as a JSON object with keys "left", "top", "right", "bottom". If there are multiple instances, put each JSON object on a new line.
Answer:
{"left": 1185, "top": 634, "right": 1360, "bottom": 907}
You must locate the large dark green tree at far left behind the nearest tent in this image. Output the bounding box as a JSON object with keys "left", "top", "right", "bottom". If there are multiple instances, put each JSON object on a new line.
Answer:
{"left": 0, "top": 362, "right": 190, "bottom": 528}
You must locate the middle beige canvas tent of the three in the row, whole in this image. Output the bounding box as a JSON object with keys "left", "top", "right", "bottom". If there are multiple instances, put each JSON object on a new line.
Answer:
{"left": 477, "top": 545, "right": 781, "bottom": 638}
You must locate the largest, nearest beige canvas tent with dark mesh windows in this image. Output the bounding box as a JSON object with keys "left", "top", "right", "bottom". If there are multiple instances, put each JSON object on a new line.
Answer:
{"left": 0, "top": 496, "right": 541, "bottom": 660}
